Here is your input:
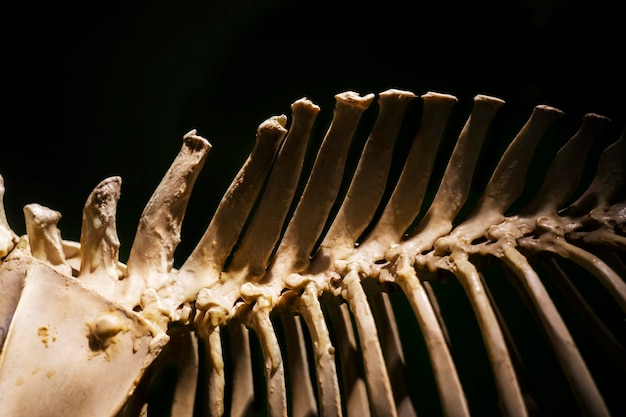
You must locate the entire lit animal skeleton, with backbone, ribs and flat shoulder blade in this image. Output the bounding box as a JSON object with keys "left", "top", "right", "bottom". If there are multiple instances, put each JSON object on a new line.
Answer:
{"left": 0, "top": 89, "right": 626, "bottom": 417}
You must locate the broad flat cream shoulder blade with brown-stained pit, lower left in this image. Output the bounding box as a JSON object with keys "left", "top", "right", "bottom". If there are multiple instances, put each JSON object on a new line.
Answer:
{"left": 0, "top": 257, "right": 168, "bottom": 416}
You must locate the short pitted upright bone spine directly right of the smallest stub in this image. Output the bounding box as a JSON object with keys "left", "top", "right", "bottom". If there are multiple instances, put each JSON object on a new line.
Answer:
{"left": 78, "top": 177, "right": 122, "bottom": 298}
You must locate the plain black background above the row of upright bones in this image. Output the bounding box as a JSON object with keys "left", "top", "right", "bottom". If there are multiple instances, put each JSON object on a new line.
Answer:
{"left": 0, "top": 0, "right": 626, "bottom": 414}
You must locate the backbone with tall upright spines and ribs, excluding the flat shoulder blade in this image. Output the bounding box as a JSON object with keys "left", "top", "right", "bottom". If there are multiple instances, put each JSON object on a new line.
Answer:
{"left": 0, "top": 90, "right": 626, "bottom": 416}
